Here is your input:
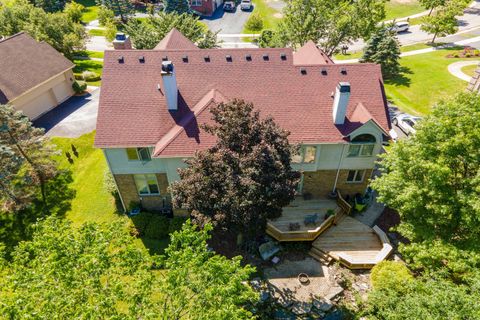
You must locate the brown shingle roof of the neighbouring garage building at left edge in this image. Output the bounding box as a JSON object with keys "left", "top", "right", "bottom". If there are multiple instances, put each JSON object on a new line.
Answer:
{"left": 0, "top": 32, "right": 74, "bottom": 103}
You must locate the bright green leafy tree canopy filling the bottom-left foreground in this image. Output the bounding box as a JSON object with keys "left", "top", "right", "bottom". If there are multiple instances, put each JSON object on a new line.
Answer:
{"left": 0, "top": 217, "right": 256, "bottom": 319}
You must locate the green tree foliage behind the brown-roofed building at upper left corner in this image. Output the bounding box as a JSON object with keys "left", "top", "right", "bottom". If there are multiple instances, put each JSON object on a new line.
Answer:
{"left": 0, "top": 0, "right": 86, "bottom": 59}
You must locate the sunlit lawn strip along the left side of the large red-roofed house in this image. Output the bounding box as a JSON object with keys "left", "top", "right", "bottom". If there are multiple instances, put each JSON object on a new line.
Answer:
{"left": 52, "top": 131, "right": 169, "bottom": 253}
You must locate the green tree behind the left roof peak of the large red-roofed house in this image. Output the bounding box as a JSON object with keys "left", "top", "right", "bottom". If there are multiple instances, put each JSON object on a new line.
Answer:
{"left": 125, "top": 12, "right": 218, "bottom": 49}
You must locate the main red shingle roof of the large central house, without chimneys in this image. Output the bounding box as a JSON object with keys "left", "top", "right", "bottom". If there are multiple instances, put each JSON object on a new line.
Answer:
{"left": 95, "top": 31, "right": 390, "bottom": 156}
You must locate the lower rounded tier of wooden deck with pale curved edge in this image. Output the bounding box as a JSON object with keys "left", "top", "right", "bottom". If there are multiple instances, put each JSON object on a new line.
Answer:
{"left": 311, "top": 216, "right": 392, "bottom": 269}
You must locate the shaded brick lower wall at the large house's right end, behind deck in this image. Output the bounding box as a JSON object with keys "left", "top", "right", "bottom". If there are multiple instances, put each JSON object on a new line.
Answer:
{"left": 302, "top": 169, "right": 373, "bottom": 198}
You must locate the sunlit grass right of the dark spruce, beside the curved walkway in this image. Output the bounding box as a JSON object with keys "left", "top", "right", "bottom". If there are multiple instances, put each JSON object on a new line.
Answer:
{"left": 385, "top": 49, "right": 467, "bottom": 115}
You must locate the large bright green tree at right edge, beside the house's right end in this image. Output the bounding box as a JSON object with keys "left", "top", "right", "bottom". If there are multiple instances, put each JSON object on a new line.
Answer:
{"left": 372, "top": 93, "right": 480, "bottom": 245}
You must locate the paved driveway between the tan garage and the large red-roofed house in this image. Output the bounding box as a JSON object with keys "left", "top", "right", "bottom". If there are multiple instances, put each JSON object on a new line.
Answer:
{"left": 33, "top": 88, "right": 100, "bottom": 138}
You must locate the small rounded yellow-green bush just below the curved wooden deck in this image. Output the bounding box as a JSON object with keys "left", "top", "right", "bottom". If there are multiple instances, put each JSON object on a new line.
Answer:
{"left": 370, "top": 261, "right": 413, "bottom": 290}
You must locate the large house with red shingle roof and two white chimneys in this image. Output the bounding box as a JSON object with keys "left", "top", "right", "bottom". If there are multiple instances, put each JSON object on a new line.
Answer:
{"left": 95, "top": 30, "right": 391, "bottom": 214}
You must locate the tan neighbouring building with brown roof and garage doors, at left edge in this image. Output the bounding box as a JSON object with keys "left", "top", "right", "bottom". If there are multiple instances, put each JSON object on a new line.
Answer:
{"left": 0, "top": 32, "right": 74, "bottom": 120}
